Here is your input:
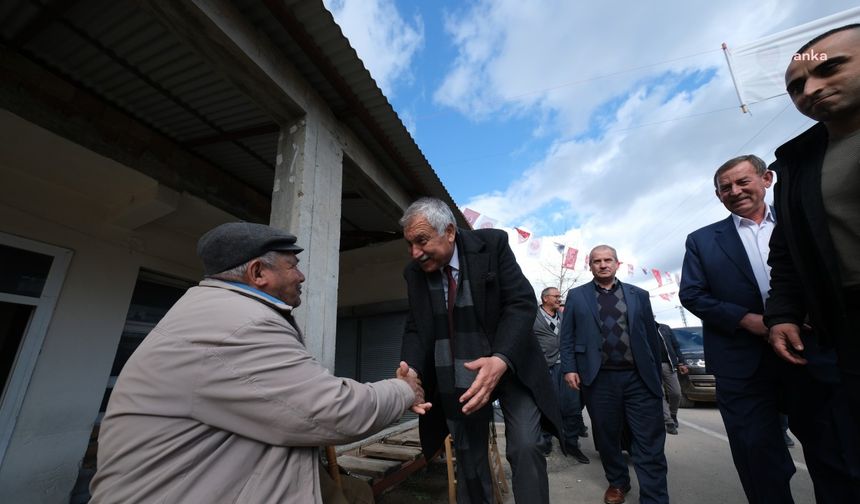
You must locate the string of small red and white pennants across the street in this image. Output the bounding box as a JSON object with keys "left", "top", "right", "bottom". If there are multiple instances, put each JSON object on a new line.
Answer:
{"left": 463, "top": 208, "right": 681, "bottom": 301}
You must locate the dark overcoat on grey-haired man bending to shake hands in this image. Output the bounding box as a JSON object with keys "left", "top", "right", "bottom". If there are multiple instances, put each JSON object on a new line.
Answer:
{"left": 401, "top": 229, "right": 561, "bottom": 458}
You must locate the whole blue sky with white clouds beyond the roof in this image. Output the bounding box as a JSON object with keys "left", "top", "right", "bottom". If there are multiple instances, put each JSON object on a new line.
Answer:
{"left": 326, "top": 0, "right": 855, "bottom": 325}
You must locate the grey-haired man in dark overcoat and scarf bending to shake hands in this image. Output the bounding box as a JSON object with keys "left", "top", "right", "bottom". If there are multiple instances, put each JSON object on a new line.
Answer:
{"left": 400, "top": 198, "right": 561, "bottom": 504}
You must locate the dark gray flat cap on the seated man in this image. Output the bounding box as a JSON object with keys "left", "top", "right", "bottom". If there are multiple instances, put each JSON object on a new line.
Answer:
{"left": 197, "top": 222, "right": 304, "bottom": 276}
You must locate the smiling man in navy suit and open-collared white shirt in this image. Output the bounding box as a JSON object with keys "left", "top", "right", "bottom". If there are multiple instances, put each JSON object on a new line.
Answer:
{"left": 679, "top": 155, "right": 845, "bottom": 504}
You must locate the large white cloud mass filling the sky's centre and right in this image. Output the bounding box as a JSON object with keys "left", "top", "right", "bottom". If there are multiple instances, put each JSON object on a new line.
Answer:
{"left": 434, "top": 0, "right": 850, "bottom": 324}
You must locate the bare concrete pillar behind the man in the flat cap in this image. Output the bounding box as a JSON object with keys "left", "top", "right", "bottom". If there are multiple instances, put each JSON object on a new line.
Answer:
{"left": 270, "top": 116, "right": 343, "bottom": 371}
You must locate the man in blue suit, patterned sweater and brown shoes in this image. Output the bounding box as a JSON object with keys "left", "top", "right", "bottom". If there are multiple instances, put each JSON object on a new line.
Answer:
{"left": 560, "top": 245, "right": 669, "bottom": 504}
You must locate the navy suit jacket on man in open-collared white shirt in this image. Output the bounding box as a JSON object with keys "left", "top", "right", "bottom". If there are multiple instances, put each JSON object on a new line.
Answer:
{"left": 678, "top": 215, "right": 770, "bottom": 378}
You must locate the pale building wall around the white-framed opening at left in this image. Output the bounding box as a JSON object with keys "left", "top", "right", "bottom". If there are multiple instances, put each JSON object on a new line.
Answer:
{"left": 0, "top": 112, "right": 235, "bottom": 504}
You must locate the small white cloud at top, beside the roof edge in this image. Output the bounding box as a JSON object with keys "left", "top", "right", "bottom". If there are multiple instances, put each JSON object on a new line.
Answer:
{"left": 324, "top": 0, "right": 424, "bottom": 99}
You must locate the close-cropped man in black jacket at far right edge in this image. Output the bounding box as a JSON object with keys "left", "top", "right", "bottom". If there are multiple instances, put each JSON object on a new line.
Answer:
{"left": 765, "top": 24, "right": 860, "bottom": 496}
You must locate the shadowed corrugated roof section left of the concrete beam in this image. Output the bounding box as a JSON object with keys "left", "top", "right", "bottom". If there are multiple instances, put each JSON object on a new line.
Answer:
{"left": 0, "top": 0, "right": 277, "bottom": 196}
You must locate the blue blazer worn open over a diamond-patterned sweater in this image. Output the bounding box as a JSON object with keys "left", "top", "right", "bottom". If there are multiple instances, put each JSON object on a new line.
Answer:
{"left": 561, "top": 282, "right": 663, "bottom": 397}
